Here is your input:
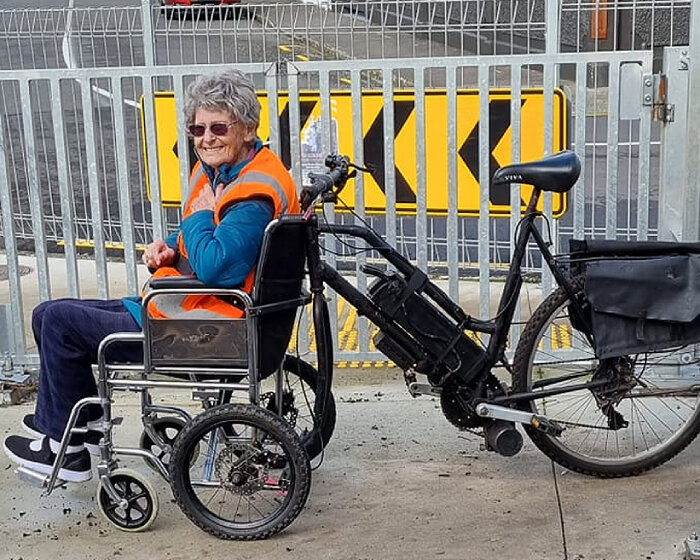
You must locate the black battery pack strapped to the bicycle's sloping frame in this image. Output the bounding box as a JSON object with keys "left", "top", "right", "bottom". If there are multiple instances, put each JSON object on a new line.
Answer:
{"left": 368, "top": 272, "right": 485, "bottom": 384}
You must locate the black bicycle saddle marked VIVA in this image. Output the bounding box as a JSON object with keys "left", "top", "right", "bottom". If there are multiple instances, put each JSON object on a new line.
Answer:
{"left": 493, "top": 150, "right": 581, "bottom": 193}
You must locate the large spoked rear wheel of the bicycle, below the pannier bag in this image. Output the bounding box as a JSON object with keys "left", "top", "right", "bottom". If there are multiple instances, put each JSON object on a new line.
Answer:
{"left": 513, "top": 280, "right": 700, "bottom": 477}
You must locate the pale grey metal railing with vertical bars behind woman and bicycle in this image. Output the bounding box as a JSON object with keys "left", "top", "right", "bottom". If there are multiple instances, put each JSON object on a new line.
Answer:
{"left": 0, "top": 52, "right": 655, "bottom": 355}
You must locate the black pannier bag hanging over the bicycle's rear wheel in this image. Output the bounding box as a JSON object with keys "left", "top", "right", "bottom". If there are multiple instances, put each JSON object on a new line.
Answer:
{"left": 571, "top": 241, "right": 700, "bottom": 358}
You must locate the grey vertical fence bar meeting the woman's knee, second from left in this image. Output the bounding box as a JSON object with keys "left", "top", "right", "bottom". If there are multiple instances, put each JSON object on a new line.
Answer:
{"left": 19, "top": 79, "right": 51, "bottom": 301}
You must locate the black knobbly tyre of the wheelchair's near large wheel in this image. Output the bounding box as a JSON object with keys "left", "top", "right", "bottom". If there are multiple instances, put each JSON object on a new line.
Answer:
{"left": 170, "top": 404, "right": 311, "bottom": 540}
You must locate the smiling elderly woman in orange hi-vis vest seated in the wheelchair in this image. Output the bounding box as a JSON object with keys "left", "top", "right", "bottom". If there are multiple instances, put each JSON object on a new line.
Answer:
{"left": 4, "top": 71, "right": 299, "bottom": 481}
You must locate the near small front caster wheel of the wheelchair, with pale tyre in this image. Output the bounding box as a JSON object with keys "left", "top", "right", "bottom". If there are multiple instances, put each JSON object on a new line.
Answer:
{"left": 97, "top": 469, "right": 158, "bottom": 533}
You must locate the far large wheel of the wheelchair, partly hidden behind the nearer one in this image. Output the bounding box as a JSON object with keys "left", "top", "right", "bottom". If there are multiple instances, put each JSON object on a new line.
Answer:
{"left": 260, "top": 355, "right": 336, "bottom": 459}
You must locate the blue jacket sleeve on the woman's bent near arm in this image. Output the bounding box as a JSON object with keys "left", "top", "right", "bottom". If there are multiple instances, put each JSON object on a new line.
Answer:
{"left": 180, "top": 200, "right": 274, "bottom": 288}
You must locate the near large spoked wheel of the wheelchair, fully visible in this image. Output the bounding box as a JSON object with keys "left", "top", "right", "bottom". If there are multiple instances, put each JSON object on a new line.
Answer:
{"left": 170, "top": 404, "right": 311, "bottom": 540}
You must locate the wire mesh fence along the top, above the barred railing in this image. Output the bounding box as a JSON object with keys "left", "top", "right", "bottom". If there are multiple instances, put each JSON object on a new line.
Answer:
{"left": 0, "top": 0, "right": 691, "bottom": 70}
